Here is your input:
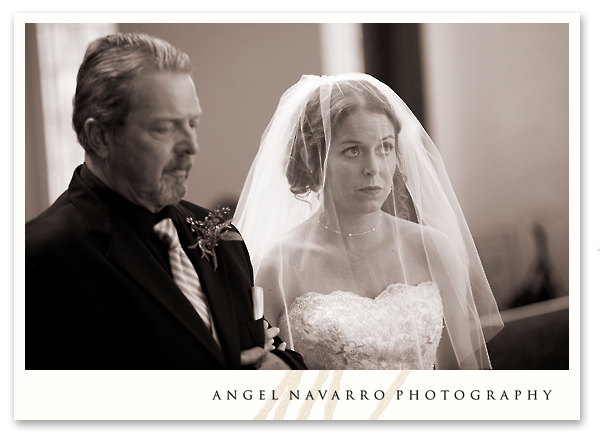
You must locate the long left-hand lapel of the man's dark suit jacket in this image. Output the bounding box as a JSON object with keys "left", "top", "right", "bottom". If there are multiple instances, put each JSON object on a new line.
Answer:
{"left": 69, "top": 173, "right": 225, "bottom": 366}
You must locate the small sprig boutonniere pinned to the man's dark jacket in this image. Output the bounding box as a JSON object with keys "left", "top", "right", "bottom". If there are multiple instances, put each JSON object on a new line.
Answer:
{"left": 186, "top": 207, "right": 242, "bottom": 271}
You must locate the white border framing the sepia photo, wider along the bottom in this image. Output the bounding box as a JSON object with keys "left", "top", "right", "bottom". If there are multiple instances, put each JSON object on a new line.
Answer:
{"left": 14, "top": 13, "right": 581, "bottom": 420}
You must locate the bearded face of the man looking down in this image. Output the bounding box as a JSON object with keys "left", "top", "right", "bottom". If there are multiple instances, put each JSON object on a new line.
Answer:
{"left": 106, "top": 72, "right": 201, "bottom": 212}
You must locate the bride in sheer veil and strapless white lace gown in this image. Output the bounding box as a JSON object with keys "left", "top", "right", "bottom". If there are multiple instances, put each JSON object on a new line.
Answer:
{"left": 233, "top": 74, "right": 503, "bottom": 370}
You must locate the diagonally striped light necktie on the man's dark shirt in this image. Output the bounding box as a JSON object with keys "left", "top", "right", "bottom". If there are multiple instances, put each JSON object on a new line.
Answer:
{"left": 154, "top": 218, "right": 220, "bottom": 345}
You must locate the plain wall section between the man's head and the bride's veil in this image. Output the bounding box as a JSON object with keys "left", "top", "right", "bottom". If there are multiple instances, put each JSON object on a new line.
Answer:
{"left": 119, "top": 23, "right": 322, "bottom": 208}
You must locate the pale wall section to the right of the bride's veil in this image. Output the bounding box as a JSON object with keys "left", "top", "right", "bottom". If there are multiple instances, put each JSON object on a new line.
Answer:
{"left": 423, "top": 24, "right": 569, "bottom": 305}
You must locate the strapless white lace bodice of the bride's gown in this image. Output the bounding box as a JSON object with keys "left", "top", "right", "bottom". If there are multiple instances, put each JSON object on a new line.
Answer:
{"left": 279, "top": 282, "right": 443, "bottom": 370}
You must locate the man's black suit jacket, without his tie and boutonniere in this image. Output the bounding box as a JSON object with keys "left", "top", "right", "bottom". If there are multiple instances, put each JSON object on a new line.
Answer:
{"left": 25, "top": 167, "right": 306, "bottom": 370}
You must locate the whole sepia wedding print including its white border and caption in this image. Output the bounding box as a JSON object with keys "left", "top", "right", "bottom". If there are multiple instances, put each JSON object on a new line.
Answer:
{"left": 15, "top": 14, "right": 579, "bottom": 419}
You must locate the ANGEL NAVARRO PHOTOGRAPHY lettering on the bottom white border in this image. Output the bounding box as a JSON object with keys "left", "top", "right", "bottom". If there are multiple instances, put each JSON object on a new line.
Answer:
{"left": 212, "top": 389, "right": 552, "bottom": 401}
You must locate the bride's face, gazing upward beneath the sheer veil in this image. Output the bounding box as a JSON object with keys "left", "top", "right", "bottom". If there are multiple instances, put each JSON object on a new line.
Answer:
{"left": 325, "top": 110, "right": 397, "bottom": 214}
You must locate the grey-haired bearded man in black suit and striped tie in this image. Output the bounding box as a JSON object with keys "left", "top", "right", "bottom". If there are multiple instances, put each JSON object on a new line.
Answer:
{"left": 25, "top": 34, "right": 305, "bottom": 369}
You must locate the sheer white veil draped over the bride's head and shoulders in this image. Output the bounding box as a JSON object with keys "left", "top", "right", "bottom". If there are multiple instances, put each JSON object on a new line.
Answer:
{"left": 233, "top": 73, "right": 503, "bottom": 369}
